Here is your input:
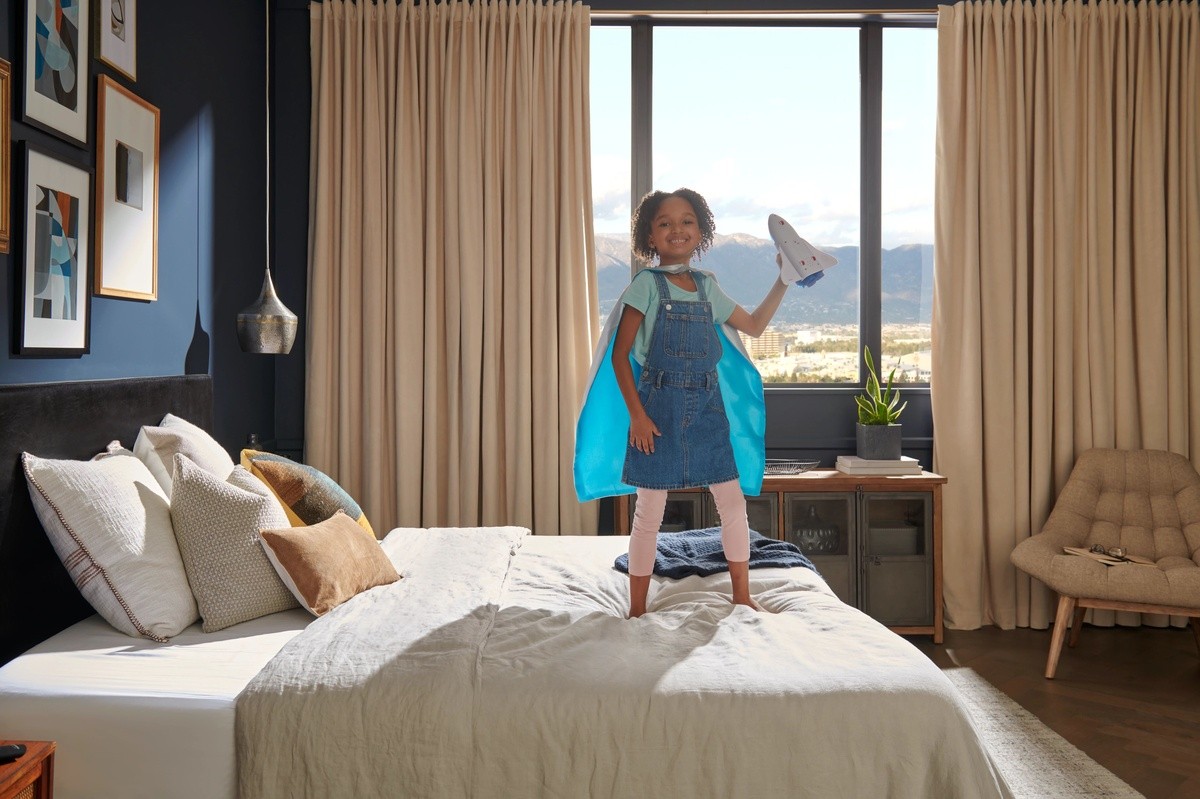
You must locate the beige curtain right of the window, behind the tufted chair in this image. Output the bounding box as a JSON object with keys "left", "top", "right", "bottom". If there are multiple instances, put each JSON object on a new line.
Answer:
{"left": 931, "top": 0, "right": 1200, "bottom": 629}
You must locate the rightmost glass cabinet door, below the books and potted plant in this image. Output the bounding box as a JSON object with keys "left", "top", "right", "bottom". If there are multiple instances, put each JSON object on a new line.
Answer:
{"left": 859, "top": 493, "right": 934, "bottom": 626}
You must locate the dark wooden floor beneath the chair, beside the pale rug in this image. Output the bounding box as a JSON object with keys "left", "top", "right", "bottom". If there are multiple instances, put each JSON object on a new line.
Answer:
{"left": 908, "top": 625, "right": 1200, "bottom": 799}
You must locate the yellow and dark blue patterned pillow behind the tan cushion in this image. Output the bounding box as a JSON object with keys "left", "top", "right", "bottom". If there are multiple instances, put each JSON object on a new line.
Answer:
{"left": 241, "top": 450, "right": 374, "bottom": 537}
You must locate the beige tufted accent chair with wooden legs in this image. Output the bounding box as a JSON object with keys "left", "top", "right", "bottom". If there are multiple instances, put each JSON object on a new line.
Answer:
{"left": 1012, "top": 450, "right": 1200, "bottom": 679}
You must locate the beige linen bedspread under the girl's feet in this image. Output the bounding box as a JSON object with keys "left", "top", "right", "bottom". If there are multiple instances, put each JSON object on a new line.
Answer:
{"left": 236, "top": 528, "right": 1009, "bottom": 799}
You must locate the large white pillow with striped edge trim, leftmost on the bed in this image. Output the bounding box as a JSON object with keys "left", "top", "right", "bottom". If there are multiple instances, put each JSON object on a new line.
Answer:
{"left": 22, "top": 452, "right": 199, "bottom": 642}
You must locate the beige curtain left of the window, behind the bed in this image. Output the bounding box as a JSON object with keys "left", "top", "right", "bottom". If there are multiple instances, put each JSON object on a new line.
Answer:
{"left": 305, "top": 0, "right": 596, "bottom": 534}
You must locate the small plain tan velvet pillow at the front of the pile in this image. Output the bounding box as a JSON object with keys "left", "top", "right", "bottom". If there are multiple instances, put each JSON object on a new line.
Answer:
{"left": 259, "top": 511, "right": 400, "bottom": 615}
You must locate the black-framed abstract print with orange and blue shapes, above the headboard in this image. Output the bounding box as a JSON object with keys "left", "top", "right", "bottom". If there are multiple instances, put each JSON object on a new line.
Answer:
{"left": 14, "top": 144, "right": 91, "bottom": 355}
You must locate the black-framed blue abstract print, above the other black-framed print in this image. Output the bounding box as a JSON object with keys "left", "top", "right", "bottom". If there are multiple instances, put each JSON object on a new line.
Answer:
{"left": 19, "top": 0, "right": 91, "bottom": 146}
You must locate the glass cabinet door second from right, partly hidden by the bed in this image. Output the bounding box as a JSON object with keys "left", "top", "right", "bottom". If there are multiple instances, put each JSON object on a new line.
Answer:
{"left": 784, "top": 493, "right": 858, "bottom": 606}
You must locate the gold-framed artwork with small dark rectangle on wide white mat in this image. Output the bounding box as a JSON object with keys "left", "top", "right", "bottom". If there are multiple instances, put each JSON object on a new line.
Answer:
{"left": 95, "top": 74, "right": 158, "bottom": 300}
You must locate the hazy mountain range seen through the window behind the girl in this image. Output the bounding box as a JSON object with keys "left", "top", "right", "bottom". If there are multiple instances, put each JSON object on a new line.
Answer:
{"left": 595, "top": 233, "right": 934, "bottom": 328}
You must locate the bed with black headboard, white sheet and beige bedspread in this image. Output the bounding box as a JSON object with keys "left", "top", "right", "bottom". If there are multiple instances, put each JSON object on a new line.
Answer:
{"left": 0, "top": 377, "right": 1009, "bottom": 799}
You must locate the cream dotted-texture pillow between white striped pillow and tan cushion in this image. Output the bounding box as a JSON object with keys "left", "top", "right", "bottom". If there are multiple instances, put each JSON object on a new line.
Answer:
{"left": 170, "top": 455, "right": 296, "bottom": 632}
